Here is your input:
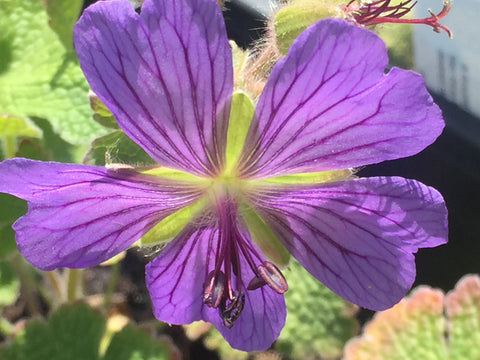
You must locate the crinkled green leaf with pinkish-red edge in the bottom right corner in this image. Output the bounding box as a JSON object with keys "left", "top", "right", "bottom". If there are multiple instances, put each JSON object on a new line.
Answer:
{"left": 344, "top": 275, "right": 480, "bottom": 360}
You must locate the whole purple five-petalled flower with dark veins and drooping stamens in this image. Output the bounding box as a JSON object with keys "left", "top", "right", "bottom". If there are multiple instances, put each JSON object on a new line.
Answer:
{"left": 0, "top": 0, "right": 447, "bottom": 350}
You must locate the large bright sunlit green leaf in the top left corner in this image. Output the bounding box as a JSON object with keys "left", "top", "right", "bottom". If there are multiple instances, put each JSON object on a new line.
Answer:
{"left": 0, "top": 0, "right": 104, "bottom": 144}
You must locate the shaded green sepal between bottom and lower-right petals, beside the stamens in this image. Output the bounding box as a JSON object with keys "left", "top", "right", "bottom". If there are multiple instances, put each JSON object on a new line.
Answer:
{"left": 240, "top": 203, "right": 290, "bottom": 268}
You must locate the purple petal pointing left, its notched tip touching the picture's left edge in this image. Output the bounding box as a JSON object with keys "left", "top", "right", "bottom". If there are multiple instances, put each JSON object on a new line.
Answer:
{"left": 0, "top": 158, "right": 198, "bottom": 270}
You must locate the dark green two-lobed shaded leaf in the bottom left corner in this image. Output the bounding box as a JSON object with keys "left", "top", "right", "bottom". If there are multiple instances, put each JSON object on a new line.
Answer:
{"left": 0, "top": 303, "right": 179, "bottom": 360}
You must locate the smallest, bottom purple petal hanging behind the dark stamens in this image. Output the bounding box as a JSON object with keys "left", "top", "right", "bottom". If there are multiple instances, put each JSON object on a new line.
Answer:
{"left": 146, "top": 228, "right": 286, "bottom": 351}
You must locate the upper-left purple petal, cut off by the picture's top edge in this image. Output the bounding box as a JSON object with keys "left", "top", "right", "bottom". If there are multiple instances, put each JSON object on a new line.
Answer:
{"left": 74, "top": 0, "right": 233, "bottom": 174}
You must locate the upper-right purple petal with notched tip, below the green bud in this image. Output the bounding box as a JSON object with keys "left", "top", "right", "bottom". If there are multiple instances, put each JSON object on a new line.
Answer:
{"left": 238, "top": 19, "right": 444, "bottom": 177}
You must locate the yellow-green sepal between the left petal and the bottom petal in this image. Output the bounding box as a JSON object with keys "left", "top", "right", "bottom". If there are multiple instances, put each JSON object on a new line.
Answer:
{"left": 140, "top": 198, "right": 205, "bottom": 246}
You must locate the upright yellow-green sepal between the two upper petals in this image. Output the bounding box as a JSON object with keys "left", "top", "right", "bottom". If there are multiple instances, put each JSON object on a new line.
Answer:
{"left": 226, "top": 91, "right": 254, "bottom": 173}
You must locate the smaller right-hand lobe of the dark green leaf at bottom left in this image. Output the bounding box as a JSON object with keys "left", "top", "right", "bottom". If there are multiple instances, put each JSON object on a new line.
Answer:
{"left": 103, "top": 325, "right": 177, "bottom": 360}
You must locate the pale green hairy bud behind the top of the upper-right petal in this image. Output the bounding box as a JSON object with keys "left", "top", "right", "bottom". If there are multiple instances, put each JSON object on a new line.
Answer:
{"left": 274, "top": 0, "right": 338, "bottom": 54}
